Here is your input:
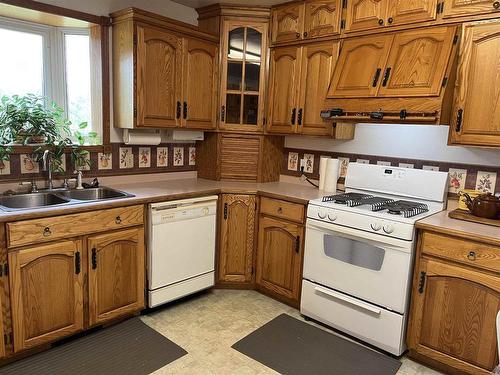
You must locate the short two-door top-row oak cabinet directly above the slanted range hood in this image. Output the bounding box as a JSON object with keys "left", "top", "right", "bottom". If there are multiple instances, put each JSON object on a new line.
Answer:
{"left": 346, "top": 0, "right": 438, "bottom": 32}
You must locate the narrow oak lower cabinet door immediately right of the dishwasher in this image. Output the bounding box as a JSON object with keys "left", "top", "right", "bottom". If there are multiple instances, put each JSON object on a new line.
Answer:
{"left": 219, "top": 194, "right": 255, "bottom": 283}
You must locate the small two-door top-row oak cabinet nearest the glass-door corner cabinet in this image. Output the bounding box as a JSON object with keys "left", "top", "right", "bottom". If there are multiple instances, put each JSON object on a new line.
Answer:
{"left": 271, "top": 0, "right": 342, "bottom": 43}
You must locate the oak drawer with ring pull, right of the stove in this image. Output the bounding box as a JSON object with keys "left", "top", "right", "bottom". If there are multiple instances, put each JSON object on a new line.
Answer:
{"left": 422, "top": 232, "right": 500, "bottom": 272}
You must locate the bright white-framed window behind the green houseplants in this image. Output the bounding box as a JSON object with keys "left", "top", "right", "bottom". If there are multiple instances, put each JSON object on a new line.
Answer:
{"left": 0, "top": 17, "right": 102, "bottom": 142}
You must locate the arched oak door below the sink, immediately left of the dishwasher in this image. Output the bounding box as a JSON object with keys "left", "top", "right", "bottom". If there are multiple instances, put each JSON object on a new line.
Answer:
{"left": 87, "top": 228, "right": 144, "bottom": 325}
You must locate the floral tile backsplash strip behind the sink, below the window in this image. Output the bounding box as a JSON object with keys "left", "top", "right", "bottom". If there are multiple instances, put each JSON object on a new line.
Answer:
{"left": 0, "top": 143, "right": 196, "bottom": 182}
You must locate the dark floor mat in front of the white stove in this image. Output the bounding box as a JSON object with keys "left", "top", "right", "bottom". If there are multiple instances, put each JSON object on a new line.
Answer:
{"left": 232, "top": 314, "right": 401, "bottom": 375}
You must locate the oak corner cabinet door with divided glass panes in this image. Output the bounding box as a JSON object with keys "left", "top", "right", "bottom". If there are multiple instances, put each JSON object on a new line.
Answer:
{"left": 219, "top": 21, "right": 268, "bottom": 132}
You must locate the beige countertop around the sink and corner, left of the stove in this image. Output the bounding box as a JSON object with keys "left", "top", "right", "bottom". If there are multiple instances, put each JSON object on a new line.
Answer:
{"left": 0, "top": 178, "right": 324, "bottom": 222}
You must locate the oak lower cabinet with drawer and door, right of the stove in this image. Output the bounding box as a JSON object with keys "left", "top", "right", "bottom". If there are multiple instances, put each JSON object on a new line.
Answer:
{"left": 408, "top": 231, "right": 500, "bottom": 375}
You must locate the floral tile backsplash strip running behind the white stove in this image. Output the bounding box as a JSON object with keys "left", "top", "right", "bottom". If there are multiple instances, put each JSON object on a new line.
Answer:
{"left": 281, "top": 148, "right": 500, "bottom": 194}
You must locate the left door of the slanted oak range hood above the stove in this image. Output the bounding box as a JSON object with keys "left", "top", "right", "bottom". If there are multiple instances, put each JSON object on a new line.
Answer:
{"left": 328, "top": 35, "right": 393, "bottom": 98}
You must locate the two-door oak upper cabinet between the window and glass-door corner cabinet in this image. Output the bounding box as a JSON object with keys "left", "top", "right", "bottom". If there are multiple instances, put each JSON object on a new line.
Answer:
{"left": 112, "top": 8, "right": 218, "bottom": 130}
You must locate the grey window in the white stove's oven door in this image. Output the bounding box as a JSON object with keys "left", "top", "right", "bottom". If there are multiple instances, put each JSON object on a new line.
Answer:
{"left": 323, "top": 234, "right": 385, "bottom": 271}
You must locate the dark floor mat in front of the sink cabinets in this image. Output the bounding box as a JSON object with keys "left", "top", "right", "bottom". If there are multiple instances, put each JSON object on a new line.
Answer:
{"left": 0, "top": 318, "right": 187, "bottom": 375}
